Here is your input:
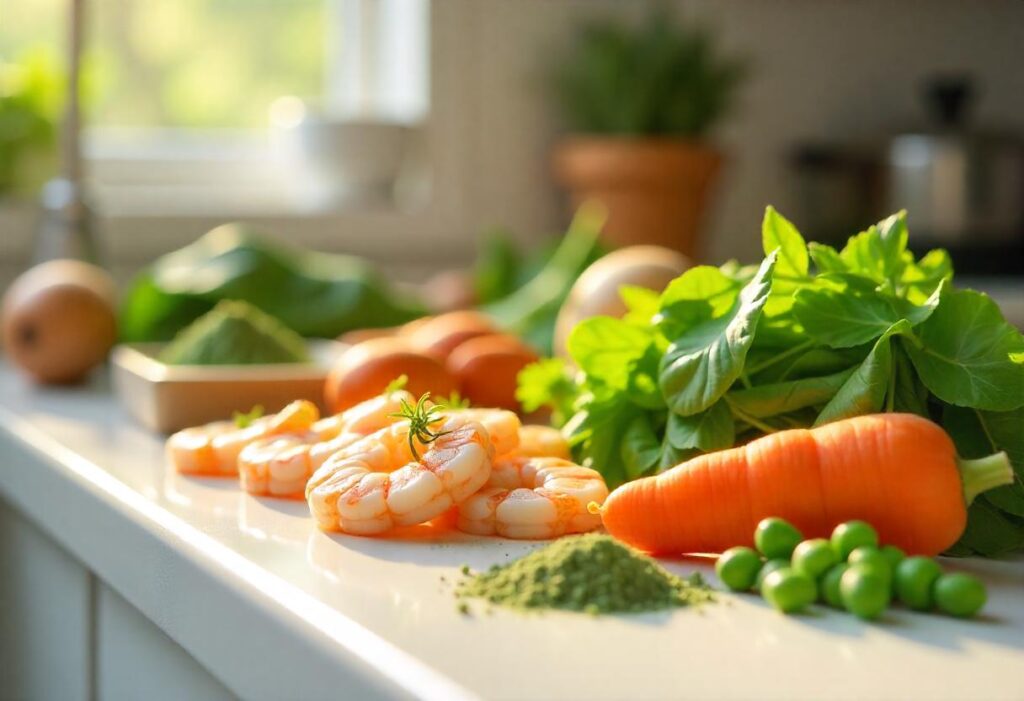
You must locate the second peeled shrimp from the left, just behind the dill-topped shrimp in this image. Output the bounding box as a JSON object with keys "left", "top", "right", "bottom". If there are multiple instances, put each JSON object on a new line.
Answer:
{"left": 239, "top": 390, "right": 415, "bottom": 499}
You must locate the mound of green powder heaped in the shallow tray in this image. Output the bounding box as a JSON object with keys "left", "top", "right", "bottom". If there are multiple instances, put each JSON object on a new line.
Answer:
{"left": 160, "top": 300, "right": 309, "bottom": 365}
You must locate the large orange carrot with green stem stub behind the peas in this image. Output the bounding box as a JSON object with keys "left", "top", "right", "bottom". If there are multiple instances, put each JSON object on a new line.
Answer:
{"left": 600, "top": 413, "right": 1014, "bottom": 555}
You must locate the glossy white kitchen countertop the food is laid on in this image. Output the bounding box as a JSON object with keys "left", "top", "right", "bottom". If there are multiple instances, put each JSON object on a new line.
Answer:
{"left": 0, "top": 368, "right": 1024, "bottom": 699}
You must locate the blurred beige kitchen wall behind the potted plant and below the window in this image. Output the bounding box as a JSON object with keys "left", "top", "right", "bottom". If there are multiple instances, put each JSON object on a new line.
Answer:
{"left": 0, "top": 0, "right": 1024, "bottom": 283}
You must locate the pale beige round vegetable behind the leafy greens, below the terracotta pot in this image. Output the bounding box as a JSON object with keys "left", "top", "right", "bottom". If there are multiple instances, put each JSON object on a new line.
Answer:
{"left": 554, "top": 246, "right": 691, "bottom": 355}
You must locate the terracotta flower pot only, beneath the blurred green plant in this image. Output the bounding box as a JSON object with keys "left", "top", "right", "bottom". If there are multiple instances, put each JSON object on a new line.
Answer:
{"left": 553, "top": 136, "right": 722, "bottom": 258}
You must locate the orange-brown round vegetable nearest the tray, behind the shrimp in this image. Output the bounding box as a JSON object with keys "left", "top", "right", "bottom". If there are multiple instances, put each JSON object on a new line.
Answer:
{"left": 324, "top": 338, "right": 458, "bottom": 411}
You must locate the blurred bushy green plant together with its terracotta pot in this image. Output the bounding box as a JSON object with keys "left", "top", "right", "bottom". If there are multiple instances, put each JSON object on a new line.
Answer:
{"left": 553, "top": 9, "right": 745, "bottom": 256}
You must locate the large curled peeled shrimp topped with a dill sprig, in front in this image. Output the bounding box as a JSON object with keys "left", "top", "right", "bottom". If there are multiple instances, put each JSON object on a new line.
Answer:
{"left": 306, "top": 411, "right": 494, "bottom": 535}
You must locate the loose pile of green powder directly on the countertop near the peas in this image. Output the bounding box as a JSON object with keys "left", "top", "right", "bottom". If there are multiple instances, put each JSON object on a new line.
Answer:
{"left": 456, "top": 534, "right": 712, "bottom": 614}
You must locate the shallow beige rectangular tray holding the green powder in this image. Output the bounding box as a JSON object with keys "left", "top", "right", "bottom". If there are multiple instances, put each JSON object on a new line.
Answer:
{"left": 111, "top": 341, "right": 345, "bottom": 433}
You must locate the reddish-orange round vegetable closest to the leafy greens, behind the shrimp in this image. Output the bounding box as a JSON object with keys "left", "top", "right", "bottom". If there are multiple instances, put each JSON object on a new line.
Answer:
{"left": 447, "top": 334, "right": 538, "bottom": 410}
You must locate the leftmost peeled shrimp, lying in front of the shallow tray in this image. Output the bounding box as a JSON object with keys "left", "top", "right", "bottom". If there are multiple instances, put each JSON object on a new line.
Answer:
{"left": 167, "top": 399, "right": 319, "bottom": 477}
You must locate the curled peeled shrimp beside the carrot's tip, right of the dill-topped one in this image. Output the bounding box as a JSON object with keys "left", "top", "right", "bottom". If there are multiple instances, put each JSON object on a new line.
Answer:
{"left": 457, "top": 456, "right": 608, "bottom": 539}
